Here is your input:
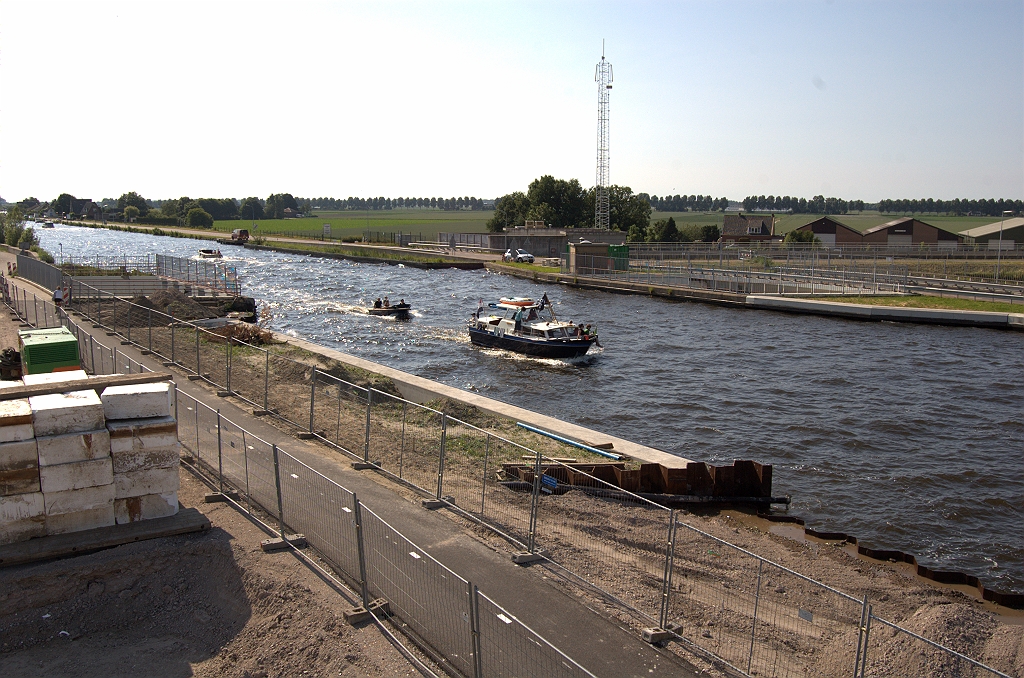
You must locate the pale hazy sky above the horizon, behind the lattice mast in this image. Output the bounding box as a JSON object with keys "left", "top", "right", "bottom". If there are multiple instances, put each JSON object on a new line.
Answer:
{"left": 0, "top": 0, "right": 1024, "bottom": 202}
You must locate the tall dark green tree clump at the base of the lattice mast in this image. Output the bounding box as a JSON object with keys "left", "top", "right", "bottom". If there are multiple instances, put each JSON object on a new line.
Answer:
{"left": 487, "top": 174, "right": 650, "bottom": 232}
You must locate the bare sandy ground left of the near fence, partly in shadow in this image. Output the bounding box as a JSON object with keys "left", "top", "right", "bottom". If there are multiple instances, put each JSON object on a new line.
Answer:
{"left": 0, "top": 470, "right": 432, "bottom": 678}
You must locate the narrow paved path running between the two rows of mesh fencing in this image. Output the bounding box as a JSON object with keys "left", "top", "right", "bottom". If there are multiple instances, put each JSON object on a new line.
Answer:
{"left": 0, "top": 264, "right": 699, "bottom": 677}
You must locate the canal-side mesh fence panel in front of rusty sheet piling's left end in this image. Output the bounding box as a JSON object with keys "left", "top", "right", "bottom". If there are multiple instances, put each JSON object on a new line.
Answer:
{"left": 522, "top": 459, "right": 672, "bottom": 620}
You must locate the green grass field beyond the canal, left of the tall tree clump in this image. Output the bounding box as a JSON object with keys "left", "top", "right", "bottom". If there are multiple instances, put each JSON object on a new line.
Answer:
{"left": 213, "top": 209, "right": 494, "bottom": 241}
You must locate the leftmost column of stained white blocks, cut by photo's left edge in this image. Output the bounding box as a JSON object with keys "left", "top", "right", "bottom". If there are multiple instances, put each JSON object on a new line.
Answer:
{"left": 0, "top": 395, "right": 46, "bottom": 544}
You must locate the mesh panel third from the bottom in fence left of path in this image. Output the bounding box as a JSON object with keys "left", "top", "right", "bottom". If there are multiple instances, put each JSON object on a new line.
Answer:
{"left": 278, "top": 450, "right": 359, "bottom": 582}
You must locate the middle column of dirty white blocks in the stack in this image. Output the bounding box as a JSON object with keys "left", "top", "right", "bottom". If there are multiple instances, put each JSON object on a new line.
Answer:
{"left": 29, "top": 391, "right": 115, "bottom": 535}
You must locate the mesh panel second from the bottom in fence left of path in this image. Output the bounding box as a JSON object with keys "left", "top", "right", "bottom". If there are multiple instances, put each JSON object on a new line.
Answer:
{"left": 360, "top": 506, "right": 473, "bottom": 675}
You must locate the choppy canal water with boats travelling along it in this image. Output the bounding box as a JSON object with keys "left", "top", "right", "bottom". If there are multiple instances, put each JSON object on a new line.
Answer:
{"left": 37, "top": 226, "right": 1024, "bottom": 592}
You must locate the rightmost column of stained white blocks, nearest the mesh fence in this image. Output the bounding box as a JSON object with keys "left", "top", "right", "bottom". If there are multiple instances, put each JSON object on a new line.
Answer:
{"left": 100, "top": 382, "right": 179, "bottom": 523}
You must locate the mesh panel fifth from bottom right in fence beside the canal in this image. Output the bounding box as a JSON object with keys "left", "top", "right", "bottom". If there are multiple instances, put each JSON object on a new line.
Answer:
{"left": 370, "top": 391, "right": 443, "bottom": 495}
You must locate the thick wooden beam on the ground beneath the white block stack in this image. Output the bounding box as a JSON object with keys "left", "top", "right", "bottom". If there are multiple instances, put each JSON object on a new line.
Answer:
{"left": 0, "top": 508, "right": 210, "bottom": 567}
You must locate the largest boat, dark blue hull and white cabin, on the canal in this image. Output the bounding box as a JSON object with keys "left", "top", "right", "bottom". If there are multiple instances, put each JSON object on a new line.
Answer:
{"left": 469, "top": 295, "right": 597, "bottom": 358}
